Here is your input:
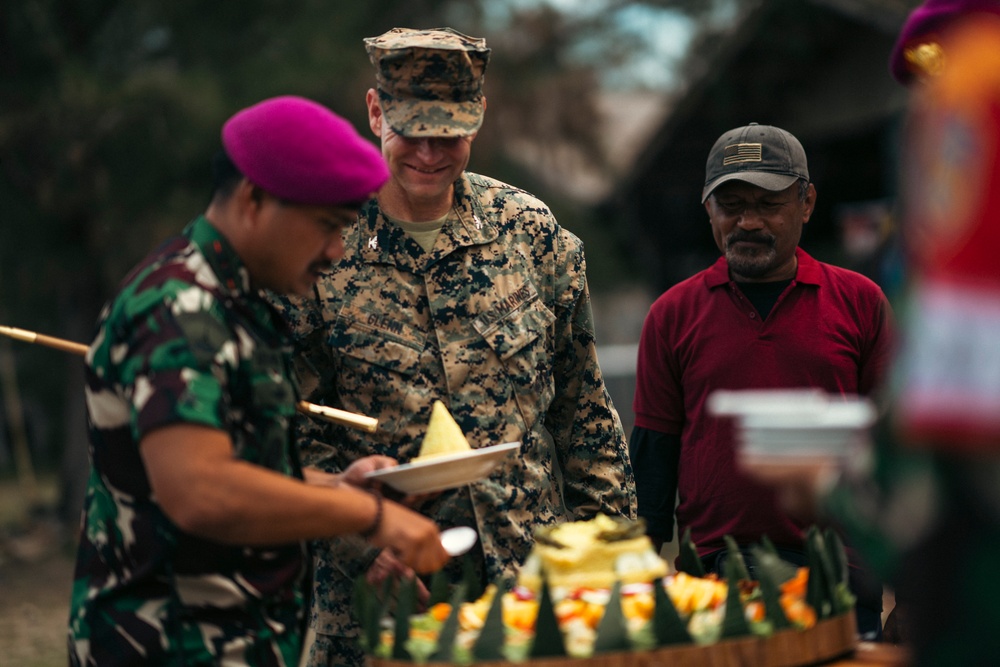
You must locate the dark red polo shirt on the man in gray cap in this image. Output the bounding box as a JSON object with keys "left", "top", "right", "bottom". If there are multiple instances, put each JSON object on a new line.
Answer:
{"left": 634, "top": 248, "right": 890, "bottom": 554}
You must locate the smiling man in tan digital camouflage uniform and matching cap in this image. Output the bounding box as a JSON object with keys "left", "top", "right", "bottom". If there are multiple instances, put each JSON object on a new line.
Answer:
{"left": 270, "top": 29, "right": 635, "bottom": 665}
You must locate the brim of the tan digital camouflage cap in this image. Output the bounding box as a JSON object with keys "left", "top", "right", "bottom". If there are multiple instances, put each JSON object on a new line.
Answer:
{"left": 379, "top": 95, "right": 483, "bottom": 139}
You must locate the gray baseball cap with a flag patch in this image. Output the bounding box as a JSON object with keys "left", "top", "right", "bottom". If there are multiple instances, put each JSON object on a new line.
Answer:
{"left": 701, "top": 123, "right": 809, "bottom": 203}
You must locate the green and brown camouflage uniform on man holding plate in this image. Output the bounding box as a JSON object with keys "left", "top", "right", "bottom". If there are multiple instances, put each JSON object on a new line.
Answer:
{"left": 69, "top": 217, "right": 309, "bottom": 666}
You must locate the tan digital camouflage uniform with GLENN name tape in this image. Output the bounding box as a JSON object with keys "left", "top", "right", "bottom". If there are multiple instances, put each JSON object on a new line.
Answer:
{"left": 270, "top": 173, "right": 635, "bottom": 662}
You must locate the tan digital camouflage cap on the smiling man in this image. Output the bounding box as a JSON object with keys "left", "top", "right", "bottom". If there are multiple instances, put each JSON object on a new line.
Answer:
{"left": 365, "top": 28, "right": 490, "bottom": 137}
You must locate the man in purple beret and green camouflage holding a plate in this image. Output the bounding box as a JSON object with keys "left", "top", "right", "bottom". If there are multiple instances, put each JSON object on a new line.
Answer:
{"left": 68, "top": 97, "right": 448, "bottom": 667}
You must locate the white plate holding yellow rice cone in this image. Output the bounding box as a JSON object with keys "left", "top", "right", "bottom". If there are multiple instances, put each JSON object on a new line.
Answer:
{"left": 365, "top": 442, "right": 521, "bottom": 493}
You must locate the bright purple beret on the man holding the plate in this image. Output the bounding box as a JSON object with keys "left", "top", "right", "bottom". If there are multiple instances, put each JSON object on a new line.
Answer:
{"left": 222, "top": 96, "right": 389, "bottom": 206}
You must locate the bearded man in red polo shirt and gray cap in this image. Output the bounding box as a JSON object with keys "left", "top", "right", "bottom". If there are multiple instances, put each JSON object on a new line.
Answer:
{"left": 630, "top": 123, "right": 891, "bottom": 637}
